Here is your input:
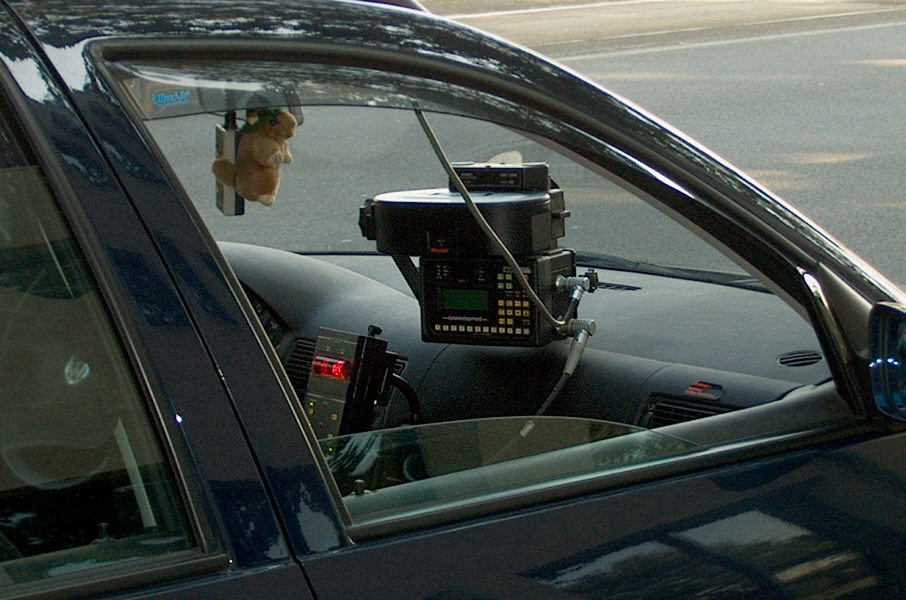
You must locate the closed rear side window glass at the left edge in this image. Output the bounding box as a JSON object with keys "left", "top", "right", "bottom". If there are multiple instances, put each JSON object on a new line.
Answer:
{"left": 0, "top": 109, "right": 194, "bottom": 584}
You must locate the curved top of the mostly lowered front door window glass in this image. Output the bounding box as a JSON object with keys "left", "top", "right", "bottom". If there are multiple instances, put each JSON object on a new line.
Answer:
{"left": 320, "top": 417, "right": 692, "bottom": 522}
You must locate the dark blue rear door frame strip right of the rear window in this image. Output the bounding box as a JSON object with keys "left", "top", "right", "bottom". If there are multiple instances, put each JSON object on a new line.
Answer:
{"left": 3, "top": 3, "right": 318, "bottom": 597}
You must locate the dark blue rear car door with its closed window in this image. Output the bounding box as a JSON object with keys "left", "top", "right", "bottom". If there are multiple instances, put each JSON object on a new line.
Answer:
{"left": 0, "top": 10, "right": 311, "bottom": 598}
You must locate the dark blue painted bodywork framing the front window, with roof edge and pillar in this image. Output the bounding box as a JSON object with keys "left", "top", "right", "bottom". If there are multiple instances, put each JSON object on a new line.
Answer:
{"left": 0, "top": 2, "right": 906, "bottom": 599}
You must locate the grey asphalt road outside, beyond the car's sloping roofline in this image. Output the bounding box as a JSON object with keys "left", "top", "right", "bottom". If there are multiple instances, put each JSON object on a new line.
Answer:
{"left": 423, "top": 0, "right": 906, "bottom": 284}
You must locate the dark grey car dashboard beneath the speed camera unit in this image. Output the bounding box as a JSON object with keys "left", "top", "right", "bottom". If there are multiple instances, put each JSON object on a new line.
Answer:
{"left": 220, "top": 242, "right": 830, "bottom": 428}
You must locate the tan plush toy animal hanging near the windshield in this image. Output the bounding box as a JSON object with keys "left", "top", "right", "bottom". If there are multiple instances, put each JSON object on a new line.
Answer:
{"left": 211, "top": 108, "right": 296, "bottom": 206}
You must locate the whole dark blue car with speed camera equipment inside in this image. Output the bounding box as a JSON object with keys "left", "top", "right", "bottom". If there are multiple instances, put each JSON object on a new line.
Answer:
{"left": 0, "top": 0, "right": 906, "bottom": 600}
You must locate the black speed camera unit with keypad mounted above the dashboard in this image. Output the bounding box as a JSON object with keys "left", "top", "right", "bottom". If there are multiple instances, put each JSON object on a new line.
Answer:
{"left": 359, "top": 163, "right": 576, "bottom": 346}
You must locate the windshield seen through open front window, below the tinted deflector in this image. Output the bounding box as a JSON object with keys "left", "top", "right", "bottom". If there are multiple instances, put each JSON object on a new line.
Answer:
{"left": 141, "top": 66, "right": 742, "bottom": 273}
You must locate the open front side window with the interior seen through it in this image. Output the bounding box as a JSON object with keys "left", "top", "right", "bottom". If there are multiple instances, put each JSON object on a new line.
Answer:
{"left": 108, "top": 60, "right": 836, "bottom": 529}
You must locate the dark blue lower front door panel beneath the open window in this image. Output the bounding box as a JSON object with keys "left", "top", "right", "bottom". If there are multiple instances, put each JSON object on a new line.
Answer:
{"left": 305, "top": 435, "right": 906, "bottom": 599}
